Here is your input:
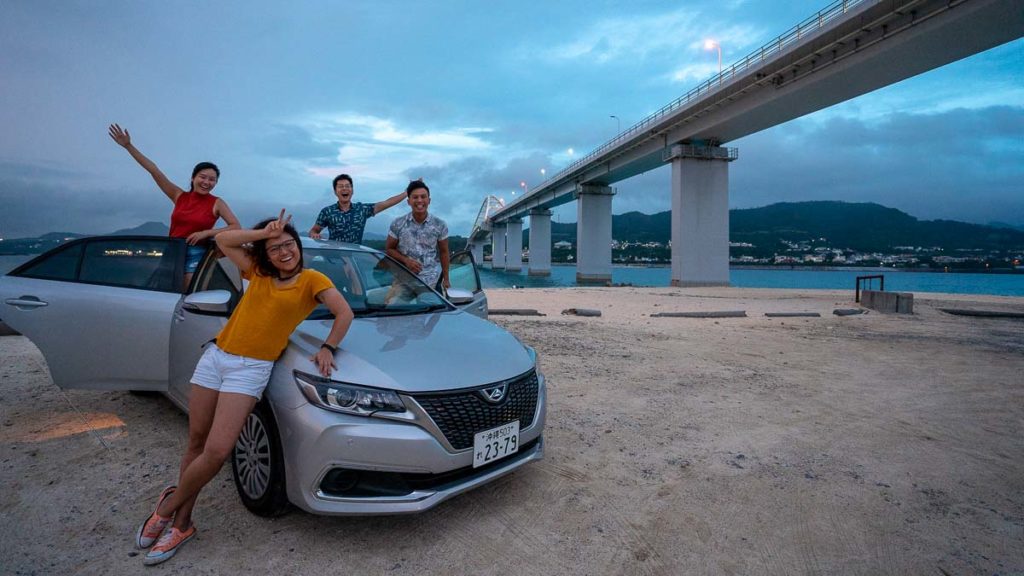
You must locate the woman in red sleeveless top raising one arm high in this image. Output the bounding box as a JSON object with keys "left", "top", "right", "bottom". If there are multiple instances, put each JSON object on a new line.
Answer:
{"left": 109, "top": 124, "right": 241, "bottom": 288}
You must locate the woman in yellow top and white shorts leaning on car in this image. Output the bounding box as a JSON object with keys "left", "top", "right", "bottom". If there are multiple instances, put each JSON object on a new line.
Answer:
{"left": 136, "top": 210, "right": 353, "bottom": 565}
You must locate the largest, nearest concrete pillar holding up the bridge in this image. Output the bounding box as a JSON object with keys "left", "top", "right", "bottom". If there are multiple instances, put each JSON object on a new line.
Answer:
{"left": 669, "top": 145, "right": 736, "bottom": 286}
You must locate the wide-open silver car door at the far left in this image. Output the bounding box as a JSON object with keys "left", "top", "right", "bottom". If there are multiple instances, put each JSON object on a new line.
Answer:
{"left": 0, "top": 236, "right": 185, "bottom": 392}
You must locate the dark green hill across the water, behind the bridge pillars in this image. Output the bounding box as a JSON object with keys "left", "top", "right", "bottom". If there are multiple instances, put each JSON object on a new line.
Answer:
{"left": 524, "top": 201, "right": 1024, "bottom": 252}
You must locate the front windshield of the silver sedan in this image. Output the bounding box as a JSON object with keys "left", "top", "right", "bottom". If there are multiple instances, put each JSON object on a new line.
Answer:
{"left": 302, "top": 248, "right": 449, "bottom": 320}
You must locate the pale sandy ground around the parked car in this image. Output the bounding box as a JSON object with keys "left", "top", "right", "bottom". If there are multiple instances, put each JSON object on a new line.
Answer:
{"left": 0, "top": 288, "right": 1024, "bottom": 575}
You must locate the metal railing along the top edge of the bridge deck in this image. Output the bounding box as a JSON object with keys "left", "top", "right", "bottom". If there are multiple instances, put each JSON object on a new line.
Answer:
{"left": 499, "top": 0, "right": 878, "bottom": 214}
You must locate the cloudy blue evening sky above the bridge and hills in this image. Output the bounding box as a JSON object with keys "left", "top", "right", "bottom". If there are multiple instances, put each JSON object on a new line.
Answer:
{"left": 0, "top": 0, "right": 1024, "bottom": 238}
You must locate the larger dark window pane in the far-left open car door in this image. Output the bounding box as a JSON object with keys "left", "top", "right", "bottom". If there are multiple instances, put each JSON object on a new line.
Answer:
{"left": 78, "top": 238, "right": 183, "bottom": 292}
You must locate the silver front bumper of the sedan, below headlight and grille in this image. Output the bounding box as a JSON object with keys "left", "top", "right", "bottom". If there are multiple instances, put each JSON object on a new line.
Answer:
{"left": 275, "top": 375, "right": 547, "bottom": 516}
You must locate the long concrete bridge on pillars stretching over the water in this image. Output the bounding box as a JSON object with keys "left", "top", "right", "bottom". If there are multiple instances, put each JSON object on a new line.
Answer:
{"left": 470, "top": 0, "right": 1024, "bottom": 286}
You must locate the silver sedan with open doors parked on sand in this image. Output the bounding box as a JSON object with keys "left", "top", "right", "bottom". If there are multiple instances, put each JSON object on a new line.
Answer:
{"left": 0, "top": 237, "right": 546, "bottom": 516}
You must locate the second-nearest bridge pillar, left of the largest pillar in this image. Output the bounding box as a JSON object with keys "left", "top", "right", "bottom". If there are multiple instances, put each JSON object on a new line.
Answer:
{"left": 577, "top": 184, "right": 614, "bottom": 283}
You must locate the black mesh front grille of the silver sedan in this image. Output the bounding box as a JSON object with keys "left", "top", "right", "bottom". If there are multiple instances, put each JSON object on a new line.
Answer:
{"left": 414, "top": 370, "right": 540, "bottom": 450}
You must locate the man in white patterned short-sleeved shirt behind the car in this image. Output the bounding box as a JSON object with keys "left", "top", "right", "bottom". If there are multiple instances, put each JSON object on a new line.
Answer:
{"left": 385, "top": 179, "right": 452, "bottom": 289}
